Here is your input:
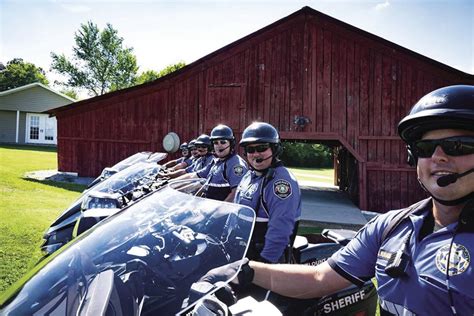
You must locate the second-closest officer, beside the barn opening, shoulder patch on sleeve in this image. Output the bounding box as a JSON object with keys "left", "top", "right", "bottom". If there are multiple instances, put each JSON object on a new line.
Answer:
{"left": 234, "top": 122, "right": 301, "bottom": 262}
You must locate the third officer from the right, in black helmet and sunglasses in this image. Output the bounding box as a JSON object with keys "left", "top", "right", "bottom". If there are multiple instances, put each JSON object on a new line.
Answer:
{"left": 179, "top": 124, "right": 247, "bottom": 202}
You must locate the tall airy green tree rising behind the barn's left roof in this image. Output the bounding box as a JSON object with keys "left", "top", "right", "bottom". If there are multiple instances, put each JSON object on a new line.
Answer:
{"left": 51, "top": 21, "right": 138, "bottom": 96}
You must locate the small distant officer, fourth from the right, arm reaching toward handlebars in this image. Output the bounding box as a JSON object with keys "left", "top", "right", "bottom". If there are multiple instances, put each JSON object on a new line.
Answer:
{"left": 160, "top": 134, "right": 213, "bottom": 179}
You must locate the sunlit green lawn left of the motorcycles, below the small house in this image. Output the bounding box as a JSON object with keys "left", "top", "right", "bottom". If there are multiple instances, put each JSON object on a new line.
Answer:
{"left": 0, "top": 146, "right": 84, "bottom": 295}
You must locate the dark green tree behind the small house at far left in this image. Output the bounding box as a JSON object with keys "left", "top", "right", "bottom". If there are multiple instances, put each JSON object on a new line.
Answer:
{"left": 0, "top": 58, "right": 49, "bottom": 91}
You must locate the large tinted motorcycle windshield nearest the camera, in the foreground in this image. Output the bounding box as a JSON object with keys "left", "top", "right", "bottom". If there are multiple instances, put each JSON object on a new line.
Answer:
{"left": 0, "top": 187, "right": 255, "bottom": 315}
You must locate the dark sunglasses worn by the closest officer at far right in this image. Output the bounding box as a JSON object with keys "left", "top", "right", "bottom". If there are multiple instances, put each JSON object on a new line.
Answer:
{"left": 411, "top": 136, "right": 474, "bottom": 158}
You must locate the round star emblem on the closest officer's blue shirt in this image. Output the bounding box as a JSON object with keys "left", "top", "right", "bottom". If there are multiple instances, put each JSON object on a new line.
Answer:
{"left": 436, "top": 243, "right": 471, "bottom": 276}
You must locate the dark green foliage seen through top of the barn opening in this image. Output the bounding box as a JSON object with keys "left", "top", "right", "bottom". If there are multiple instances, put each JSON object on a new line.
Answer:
{"left": 280, "top": 142, "right": 333, "bottom": 168}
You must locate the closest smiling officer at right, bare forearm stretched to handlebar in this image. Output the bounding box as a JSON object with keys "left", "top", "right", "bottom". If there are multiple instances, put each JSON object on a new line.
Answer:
{"left": 231, "top": 85, "right": 474, "bottom": 315}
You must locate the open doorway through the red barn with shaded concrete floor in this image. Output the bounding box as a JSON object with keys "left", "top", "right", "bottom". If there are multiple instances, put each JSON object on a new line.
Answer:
{"left": 282, "top": 139, "right": 367, "bottom": 230}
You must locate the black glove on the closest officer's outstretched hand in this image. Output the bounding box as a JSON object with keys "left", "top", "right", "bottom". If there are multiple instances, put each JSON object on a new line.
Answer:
{"left": 199, "top": 258, "right": 254, "bottom": 286}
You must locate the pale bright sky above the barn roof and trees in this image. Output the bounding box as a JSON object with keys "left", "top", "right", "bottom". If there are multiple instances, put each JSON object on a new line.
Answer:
{"left": 0, "top": 0, "right": 474, "bottom": 93}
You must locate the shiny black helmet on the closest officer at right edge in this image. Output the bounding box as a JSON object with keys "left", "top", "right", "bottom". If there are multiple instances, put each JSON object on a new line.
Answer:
{"left": 398, "top": 85, "right": 474, "bottom": 144}
